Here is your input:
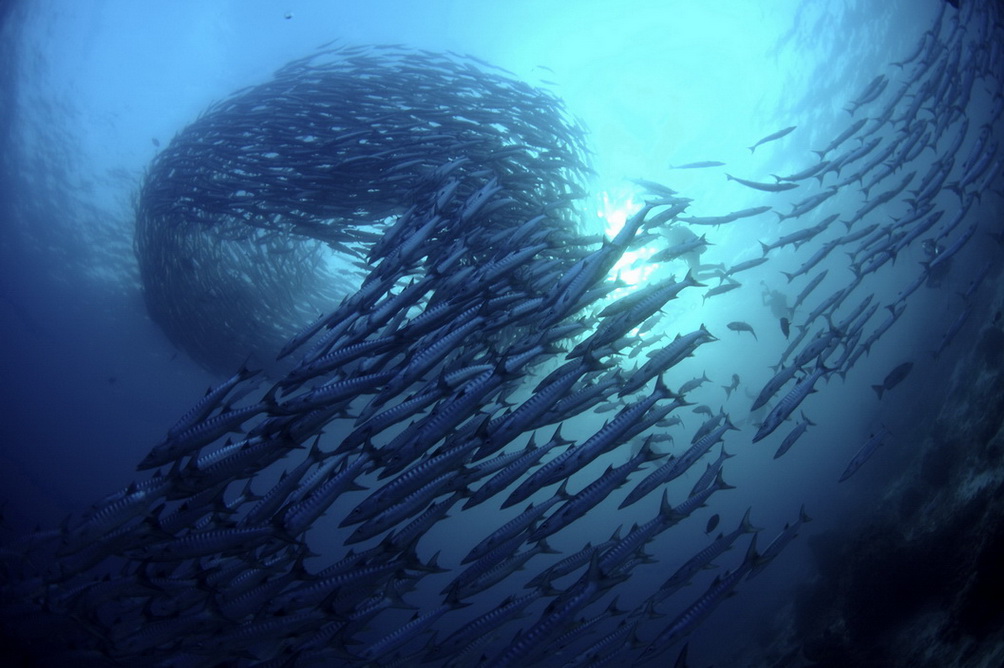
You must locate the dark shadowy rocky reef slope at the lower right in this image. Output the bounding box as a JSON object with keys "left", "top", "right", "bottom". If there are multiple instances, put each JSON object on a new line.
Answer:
{"left": 769, "top": 273, "right": 1004, "bottom": 668}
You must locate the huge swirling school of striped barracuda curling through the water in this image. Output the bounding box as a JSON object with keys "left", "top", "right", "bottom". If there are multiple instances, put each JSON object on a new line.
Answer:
{"left": 0, "top": 2, "right": 1004, "bottom": 667}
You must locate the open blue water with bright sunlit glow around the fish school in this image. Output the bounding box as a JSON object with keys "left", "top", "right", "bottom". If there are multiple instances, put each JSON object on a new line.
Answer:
{"left": 0, "top": 0, "right": 1001, "bottom": 666}
